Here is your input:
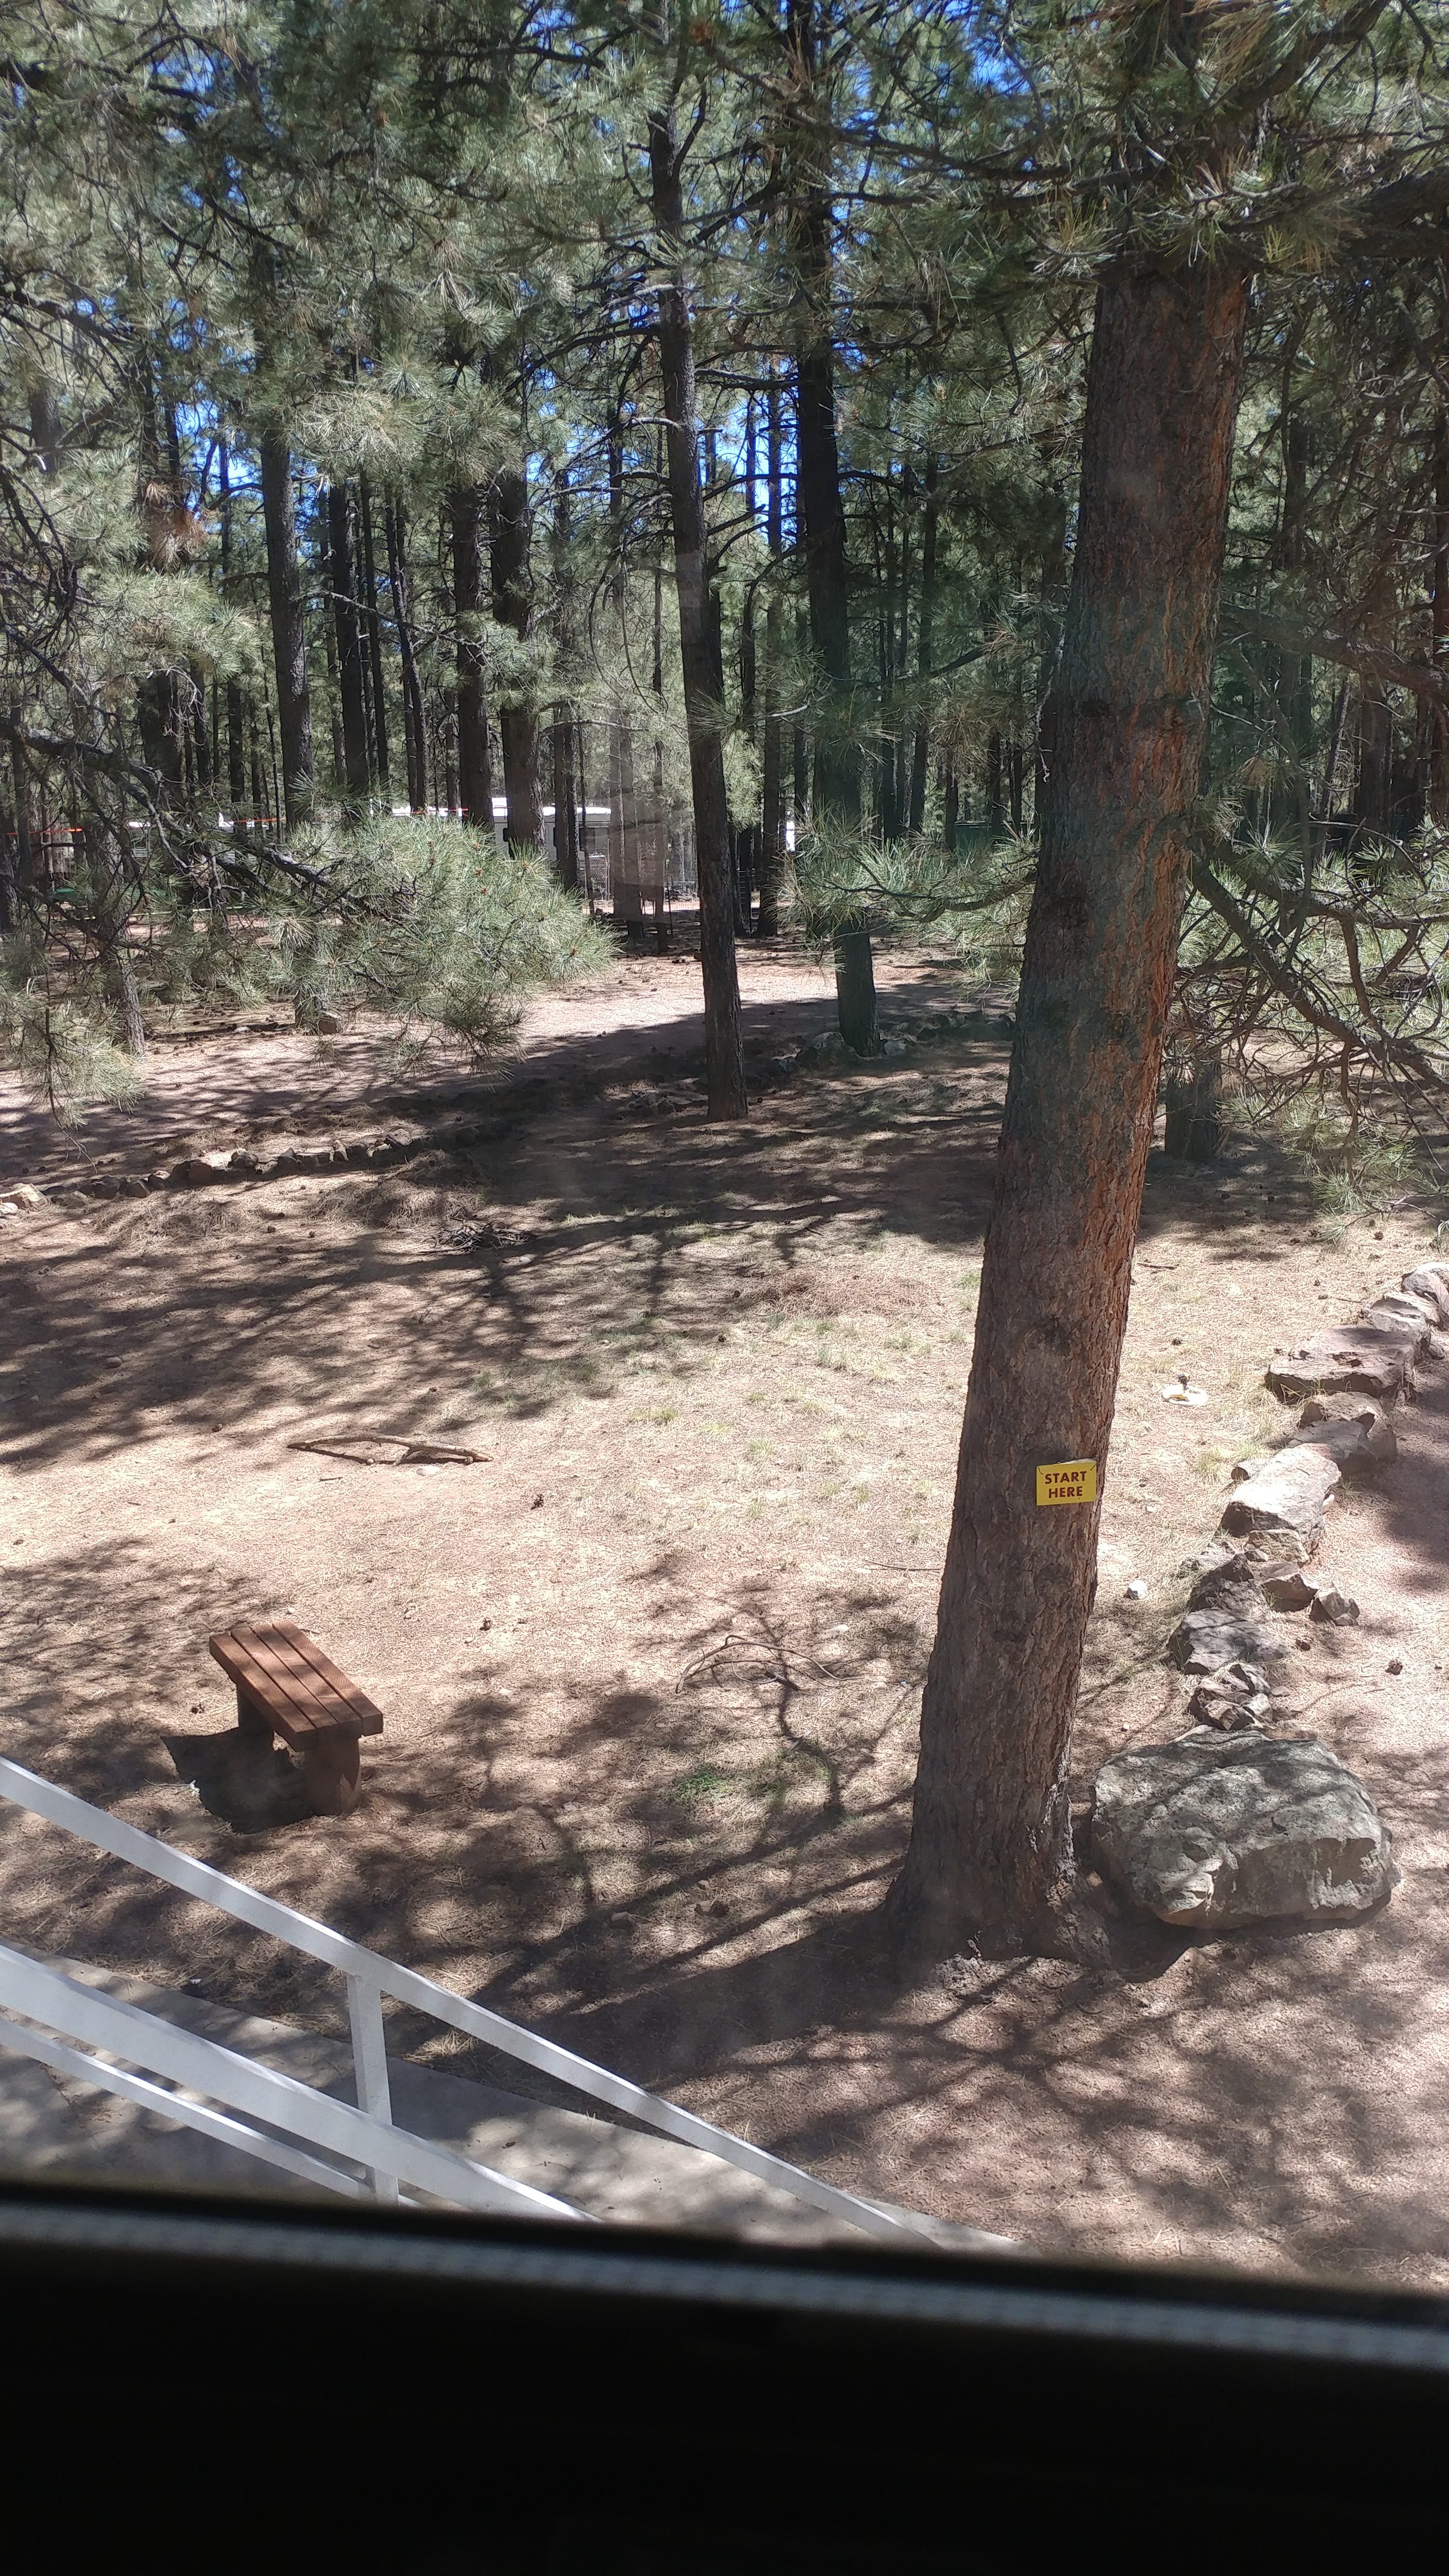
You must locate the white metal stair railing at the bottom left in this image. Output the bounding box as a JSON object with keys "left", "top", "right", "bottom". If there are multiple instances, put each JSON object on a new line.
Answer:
{"left": 0, "top": 1759, "right": 931, "bottom": 2243}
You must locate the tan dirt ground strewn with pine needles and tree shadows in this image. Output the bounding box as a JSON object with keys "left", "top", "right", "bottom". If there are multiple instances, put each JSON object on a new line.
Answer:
{"left": 0, "top": 953, "right": 1449, "bottom": 2287}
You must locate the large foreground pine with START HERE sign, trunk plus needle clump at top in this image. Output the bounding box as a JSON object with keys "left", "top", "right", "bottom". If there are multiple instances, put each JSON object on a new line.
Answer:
{"left": 889, "top": 0, "right": 1449, "bottom": 1953}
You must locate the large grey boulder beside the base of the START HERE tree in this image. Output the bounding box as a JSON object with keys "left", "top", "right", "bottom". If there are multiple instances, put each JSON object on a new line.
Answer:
{"left": 1090, "top": 1726, "right": 1397, "bottom": 1932}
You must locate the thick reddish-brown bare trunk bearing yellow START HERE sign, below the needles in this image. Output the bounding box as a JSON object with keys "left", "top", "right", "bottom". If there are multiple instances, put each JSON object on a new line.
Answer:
{"left": 892, "top": 260, "right": 1248, "bottom": 1950}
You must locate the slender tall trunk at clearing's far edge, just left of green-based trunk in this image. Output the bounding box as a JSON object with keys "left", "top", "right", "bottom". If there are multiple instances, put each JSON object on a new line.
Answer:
{"left": 650, "top": 105, "right": 750, "bottom": 1118}
